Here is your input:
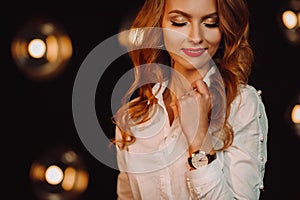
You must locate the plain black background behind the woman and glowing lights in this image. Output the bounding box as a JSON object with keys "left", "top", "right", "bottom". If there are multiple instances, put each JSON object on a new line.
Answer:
{"left": 0, "top": 0, "right": 300, "bottom": 200}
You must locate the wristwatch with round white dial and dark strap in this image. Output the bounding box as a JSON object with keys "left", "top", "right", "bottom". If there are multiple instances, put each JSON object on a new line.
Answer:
{"left": 188, "top": 150, "right": 217, "bottom": 169}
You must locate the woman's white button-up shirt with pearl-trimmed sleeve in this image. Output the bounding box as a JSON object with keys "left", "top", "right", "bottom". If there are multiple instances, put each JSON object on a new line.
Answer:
{"left": 116, "top": 76, "right": 268, "bottom": 200}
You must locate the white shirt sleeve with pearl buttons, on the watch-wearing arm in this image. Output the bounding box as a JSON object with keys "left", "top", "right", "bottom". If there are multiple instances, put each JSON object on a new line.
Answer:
{"left": 187, "top": 86, "right": 268, "bottom": 200}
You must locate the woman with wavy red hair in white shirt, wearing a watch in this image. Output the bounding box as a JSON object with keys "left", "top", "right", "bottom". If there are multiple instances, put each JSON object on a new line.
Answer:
{"left": 114, "top": 0, "right": 268, "bottom": 200}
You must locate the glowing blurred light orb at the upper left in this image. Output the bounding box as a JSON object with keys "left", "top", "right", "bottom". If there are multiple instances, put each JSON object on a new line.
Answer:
{"left": 11, "top": 19, "right": 73, "bottom": 80}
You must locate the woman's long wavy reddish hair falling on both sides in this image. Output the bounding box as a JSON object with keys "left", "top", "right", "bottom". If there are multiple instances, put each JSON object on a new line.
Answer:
{"left": 112, "top": 0, "right": 253, "bottom": 149}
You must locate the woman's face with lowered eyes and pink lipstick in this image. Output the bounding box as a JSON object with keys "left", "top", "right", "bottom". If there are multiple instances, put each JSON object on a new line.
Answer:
{"left": 162, "top": 0, "right": 222, "bottom": 72}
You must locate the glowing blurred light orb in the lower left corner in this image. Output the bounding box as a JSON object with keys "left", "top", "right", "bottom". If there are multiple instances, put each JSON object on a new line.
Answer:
{"left": 29, "top": 147, "right": 89, "bottom": 200}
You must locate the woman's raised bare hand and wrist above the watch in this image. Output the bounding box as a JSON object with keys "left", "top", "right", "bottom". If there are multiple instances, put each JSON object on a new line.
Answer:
{"left": 177, "top": 79, "right": 212, "bottom": 152}
